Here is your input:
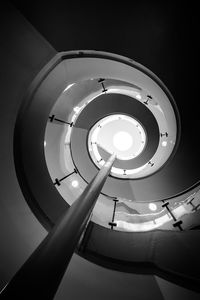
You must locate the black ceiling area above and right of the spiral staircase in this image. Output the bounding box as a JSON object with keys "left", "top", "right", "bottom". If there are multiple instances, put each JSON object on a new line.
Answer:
{"left": 11, "top": 1, "right": 200, "bottom": 184}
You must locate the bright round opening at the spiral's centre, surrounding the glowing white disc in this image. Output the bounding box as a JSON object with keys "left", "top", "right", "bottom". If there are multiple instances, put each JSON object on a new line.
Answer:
{"left": 88, "top": 114, "right": 146, "bottom": 164}
